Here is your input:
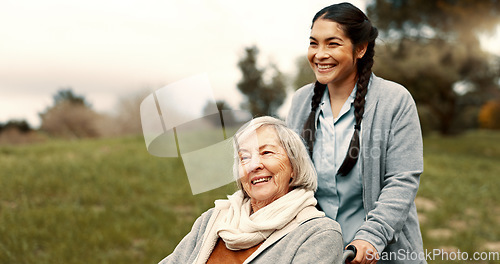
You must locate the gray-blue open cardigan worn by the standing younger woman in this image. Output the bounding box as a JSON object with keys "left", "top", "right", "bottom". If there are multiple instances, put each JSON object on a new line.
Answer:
{"left": 287, "top": 75, "right": 425, "bottom": 263}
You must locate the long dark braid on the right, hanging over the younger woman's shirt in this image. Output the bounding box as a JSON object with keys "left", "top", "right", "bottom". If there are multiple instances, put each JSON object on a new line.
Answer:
{"left": 337, "top": 41, "right": 375, "bottom": 176}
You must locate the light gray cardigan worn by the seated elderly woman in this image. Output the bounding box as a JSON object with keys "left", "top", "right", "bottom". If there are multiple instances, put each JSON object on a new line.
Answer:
{"left": 159, "top": 207, "right": 343, "bottom": 264}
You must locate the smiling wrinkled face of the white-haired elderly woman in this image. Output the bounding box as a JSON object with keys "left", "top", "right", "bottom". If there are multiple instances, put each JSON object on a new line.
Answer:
{"left": 238, "top": 126, "right": 292, "bottom": 207}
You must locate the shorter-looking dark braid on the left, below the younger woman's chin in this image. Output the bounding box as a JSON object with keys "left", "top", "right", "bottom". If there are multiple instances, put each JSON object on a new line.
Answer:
{"left": 302, "top": 81, "right": 326, "bottom": 157}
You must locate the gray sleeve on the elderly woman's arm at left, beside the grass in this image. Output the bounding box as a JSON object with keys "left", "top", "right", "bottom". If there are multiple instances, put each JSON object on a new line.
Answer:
{"left": 159, "top": 209, "right": 213, "bottom": 264}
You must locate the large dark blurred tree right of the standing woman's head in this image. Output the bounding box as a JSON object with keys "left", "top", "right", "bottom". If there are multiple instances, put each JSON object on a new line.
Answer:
{"left": 367, "top": 0, "right": 500, "bottom": 134}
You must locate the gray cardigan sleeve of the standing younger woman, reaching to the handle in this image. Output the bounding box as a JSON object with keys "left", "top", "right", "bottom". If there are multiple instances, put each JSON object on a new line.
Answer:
{"left": 354, "top": 88, "right": 423, "bottom": 252}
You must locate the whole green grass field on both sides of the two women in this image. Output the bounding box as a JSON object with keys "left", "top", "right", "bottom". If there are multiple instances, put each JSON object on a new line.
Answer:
{"left": 0, "top": 131, "right": 500, "bottom": 264}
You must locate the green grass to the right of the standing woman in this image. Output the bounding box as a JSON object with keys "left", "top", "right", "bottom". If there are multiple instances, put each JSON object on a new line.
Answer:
{"left": 418, "top": 131, "right": 500, "bottom": 263}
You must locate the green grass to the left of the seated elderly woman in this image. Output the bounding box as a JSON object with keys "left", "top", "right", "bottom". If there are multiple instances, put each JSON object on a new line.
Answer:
{"left": 0, "top": 137, "right": 234, "bottom": 264}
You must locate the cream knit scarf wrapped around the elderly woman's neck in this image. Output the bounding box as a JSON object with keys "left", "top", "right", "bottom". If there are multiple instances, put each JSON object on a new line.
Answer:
{"left": 216, "top": 189, "right": 324, "bottom": 250}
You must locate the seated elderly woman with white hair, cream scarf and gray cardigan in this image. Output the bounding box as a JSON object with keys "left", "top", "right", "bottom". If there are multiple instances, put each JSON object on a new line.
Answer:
{"left": 160, "top": 117, "right": 343, "bottom": 264}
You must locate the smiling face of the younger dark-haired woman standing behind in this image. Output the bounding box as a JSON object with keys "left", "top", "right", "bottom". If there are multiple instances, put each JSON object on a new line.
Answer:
{"left": 307, "top": 18, "right": 364, "bottom": 87}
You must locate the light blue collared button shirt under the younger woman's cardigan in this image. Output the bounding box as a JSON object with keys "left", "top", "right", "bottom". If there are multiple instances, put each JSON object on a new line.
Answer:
{"left": 313, "top": 87, "right": 365, "bottom": 245}
